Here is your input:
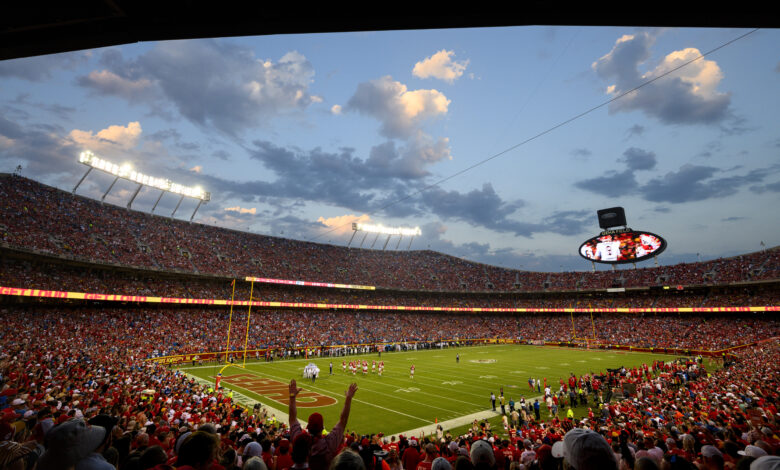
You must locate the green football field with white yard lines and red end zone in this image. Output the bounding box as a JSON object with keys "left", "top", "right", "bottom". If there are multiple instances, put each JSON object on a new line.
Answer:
{"left": 181, "top": 345, "right": 674, "bottom": 434}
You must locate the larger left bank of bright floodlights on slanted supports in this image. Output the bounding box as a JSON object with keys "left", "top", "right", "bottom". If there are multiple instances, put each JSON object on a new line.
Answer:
{"left": 72, "top": 150, "right": 211, "bottom": 222}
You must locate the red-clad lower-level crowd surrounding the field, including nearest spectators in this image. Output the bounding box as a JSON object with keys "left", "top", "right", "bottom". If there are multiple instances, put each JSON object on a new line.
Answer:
{"left": 0, "top": 307, "right": 780, "bottom": 470}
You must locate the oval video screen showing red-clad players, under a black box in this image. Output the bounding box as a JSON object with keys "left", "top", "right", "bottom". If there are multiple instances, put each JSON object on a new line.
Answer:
{"left": 580, "top": 232, "right": 666, "bottom": 263}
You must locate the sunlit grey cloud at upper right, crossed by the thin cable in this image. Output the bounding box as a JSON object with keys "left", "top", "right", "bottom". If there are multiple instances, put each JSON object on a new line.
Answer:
{"left": 592, "top": 32, "right": 731, "bottom": 124}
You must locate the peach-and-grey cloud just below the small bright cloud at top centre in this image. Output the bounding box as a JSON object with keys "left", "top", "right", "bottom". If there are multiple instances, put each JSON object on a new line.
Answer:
{"left": 346, "top": 76, "right": 450, "bottom": 139}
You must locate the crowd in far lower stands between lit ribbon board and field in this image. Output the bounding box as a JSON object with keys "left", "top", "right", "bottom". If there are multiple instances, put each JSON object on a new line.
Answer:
{"left": 0, "top": 304, "right": 780, "bottom": 358}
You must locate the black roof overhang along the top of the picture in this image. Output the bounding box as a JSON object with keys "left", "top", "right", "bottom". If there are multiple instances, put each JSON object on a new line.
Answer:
{"left": 0, "top": 0, "right": 780, "bottom": 60}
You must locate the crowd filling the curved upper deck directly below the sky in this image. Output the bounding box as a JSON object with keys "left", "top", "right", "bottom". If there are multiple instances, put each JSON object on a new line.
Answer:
{"left": 0, "top": 175, "right": 780, "bottom": 291}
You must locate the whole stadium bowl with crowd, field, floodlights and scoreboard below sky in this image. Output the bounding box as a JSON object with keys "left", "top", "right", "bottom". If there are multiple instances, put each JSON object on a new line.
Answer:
{"left": 0, "top": 8, "right": 780, "bottom": 470}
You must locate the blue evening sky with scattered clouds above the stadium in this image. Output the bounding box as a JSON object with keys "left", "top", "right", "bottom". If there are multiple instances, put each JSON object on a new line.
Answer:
{"left": 0, "top": 26, "right": 780, "bottom": 271}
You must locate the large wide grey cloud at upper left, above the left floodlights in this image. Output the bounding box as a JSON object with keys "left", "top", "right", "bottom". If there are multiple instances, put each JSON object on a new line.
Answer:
{"left": 77, "top": 39, "right": 321, "bottom": 136}
